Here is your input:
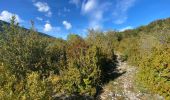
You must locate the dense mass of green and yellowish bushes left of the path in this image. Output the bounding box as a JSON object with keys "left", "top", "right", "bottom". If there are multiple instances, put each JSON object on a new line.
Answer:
{"left": 0, "top": 17, "right": 116, "bottom": 100}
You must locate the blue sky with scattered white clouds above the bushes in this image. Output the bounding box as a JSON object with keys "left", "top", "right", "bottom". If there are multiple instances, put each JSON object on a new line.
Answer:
{"left": 0, "top": 0, "right": 170, "bottom": 39}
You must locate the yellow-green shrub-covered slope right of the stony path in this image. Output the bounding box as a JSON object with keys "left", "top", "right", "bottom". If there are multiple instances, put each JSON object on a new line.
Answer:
{"left": 108, "top": 19, "right": 170, "bottom": 100}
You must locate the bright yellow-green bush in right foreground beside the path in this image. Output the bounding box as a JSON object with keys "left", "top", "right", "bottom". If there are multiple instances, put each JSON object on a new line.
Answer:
{"left": 138, "top": 45, "right": 170, "bottom": 100}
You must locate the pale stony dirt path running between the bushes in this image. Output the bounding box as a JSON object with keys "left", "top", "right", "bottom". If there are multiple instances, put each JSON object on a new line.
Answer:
{"left": 100, "top": 55, "right": 164, "bottom": 100}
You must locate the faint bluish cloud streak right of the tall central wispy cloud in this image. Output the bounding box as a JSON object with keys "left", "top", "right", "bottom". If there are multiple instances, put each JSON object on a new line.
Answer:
{"left": 112, "top": 0, "right": 135, "bottom": 24}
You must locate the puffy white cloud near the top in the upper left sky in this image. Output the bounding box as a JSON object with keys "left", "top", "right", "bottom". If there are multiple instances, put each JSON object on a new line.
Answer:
{"left": 34, "top": 2, "right": 52, "bottom": 17}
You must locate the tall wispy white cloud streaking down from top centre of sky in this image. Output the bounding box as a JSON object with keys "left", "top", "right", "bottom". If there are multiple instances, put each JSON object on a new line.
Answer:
{"left": 81, "top": 0, "right": 110, "bottom": 29}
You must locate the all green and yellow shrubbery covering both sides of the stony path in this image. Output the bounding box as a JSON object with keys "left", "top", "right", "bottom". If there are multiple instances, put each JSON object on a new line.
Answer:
{"left": 0, "top": 17, "right": 170, "bottom": 100}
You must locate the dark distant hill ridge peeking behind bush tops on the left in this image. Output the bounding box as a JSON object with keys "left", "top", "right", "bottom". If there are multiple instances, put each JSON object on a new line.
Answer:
{"left": 0, "top": 20, "right": 54, "bottom": 38}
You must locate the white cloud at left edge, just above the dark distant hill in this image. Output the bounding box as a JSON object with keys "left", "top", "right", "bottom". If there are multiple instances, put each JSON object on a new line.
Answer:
{"left": 0, "top": 10, "right": 23, "bottom": 22}
